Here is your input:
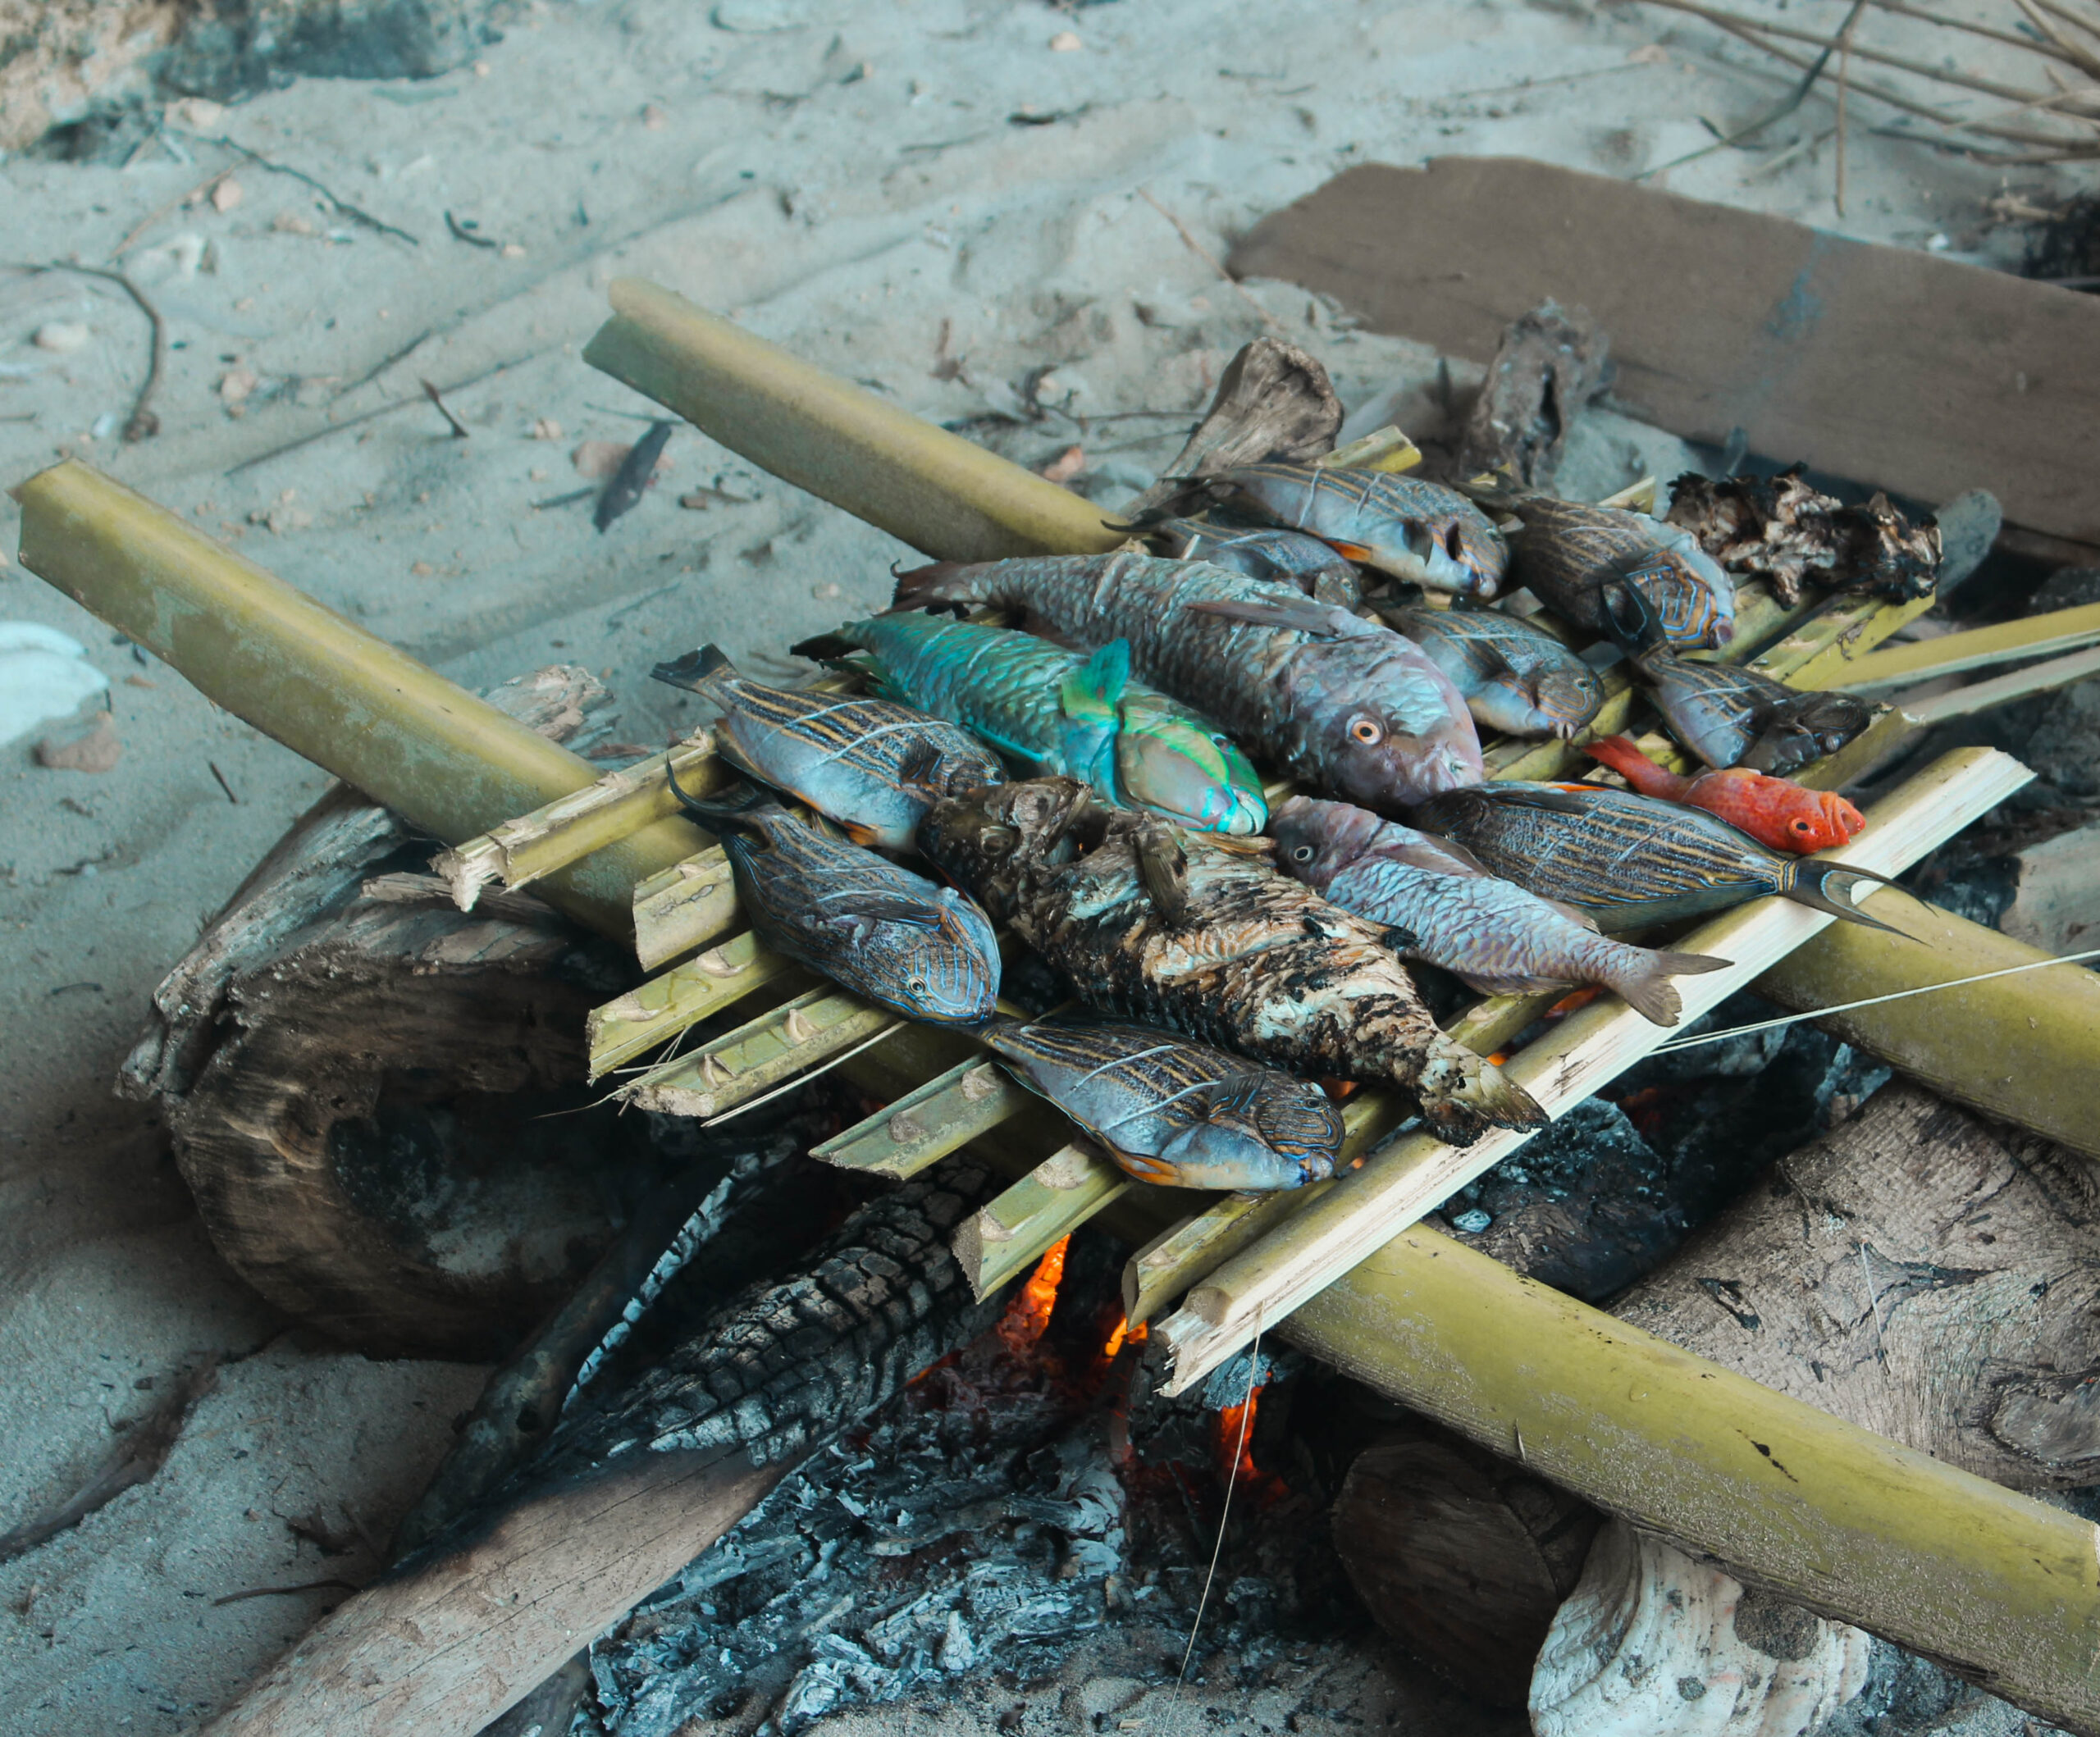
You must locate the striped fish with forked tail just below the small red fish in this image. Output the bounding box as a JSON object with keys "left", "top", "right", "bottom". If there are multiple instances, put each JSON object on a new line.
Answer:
{"left": 1415, "top": 782, "right": 1901, "bottom": 932}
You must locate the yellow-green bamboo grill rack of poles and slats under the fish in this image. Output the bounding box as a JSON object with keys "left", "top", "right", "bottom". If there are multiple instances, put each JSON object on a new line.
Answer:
{"left": 16, "top": 281, "right": 2100, "bottom": 1730}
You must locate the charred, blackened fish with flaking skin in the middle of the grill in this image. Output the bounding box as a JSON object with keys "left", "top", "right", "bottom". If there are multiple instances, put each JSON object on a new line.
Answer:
{"left": 920, "top": 777, "right": 1545, "bottom": 1145}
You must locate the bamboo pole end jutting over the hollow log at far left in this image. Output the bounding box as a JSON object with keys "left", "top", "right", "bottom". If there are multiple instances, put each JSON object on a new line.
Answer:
{"left": 15, "top": 460, "right": 708, "bottom": 937}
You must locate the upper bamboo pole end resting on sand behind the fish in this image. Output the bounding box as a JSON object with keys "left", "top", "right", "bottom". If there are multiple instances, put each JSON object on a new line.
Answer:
{"left": 584, "top": 277, "right": 1124, "bottom": 561}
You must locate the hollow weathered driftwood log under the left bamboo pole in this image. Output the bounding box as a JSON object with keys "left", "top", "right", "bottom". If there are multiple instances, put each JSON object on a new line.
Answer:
{"left": 133, "top": 668, "right": 634, "bottom": 1359}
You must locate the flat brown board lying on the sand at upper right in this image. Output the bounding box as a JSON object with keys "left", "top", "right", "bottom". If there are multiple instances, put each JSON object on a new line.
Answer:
{"left": 1229, "top": 157, "right": 2100, "bottom": 544}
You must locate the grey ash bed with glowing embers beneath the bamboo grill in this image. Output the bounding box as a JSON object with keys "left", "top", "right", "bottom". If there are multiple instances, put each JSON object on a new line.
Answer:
{"left": 569, "top": 1233, "right": 1367, "bottom": 1737}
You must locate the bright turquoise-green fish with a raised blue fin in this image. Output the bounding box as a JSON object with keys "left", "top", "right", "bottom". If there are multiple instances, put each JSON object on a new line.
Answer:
{"left": 796, "top": 615, "right": 1268, "bottom": 834}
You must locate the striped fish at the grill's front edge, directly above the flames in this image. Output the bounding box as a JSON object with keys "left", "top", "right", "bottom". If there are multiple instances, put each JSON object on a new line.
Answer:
{"left": 985, "top": 1019, "right": 1342, "bottom": 1191}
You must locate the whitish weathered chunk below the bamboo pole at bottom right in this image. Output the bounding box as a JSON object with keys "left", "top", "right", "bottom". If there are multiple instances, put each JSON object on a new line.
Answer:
{"left": 1531, "top": 1520, "right": 1869, "bottom": 1737}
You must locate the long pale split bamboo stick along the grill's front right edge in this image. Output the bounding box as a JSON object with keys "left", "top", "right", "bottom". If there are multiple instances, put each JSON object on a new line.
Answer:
{"left": 1159, "top": 748, "right": 2033, "bottom": 1393}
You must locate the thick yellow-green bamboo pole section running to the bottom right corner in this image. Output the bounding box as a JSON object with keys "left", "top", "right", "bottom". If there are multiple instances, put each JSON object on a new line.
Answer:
{"left": 1271, "top": 1224, "right": 2100, "bottom": 1733}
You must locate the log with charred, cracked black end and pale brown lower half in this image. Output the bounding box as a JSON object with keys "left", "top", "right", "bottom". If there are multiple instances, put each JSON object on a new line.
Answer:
{"left": 208, "top": 1160, "right": 1002, "bottom": 1737}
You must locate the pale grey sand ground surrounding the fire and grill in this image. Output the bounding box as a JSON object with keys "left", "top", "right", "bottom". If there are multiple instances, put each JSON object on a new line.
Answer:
{"left": 0, "top": 0, "right": 2058, "bottom": 1737}
